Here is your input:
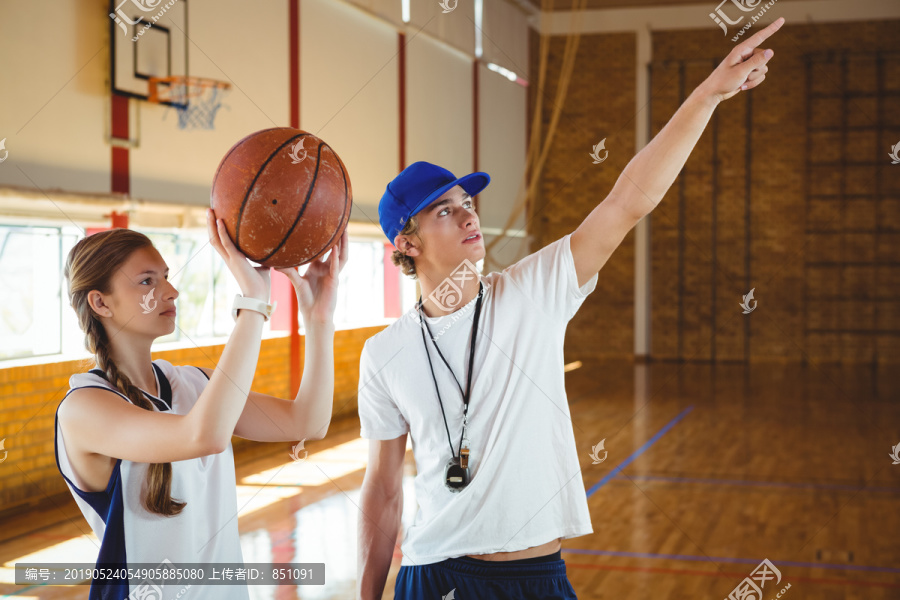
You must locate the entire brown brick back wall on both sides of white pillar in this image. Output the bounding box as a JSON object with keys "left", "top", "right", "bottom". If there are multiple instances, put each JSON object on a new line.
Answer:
{"left": 529, "top": 21, "right": 900, "bottom": 363}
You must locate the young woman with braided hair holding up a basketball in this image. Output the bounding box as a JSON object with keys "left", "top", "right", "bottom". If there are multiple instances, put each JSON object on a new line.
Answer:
{"left": 56, "top": 210, "right": 347, "bottom": 599}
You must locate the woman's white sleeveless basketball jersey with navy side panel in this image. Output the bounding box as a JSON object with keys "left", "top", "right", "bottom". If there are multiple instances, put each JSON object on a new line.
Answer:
{"left": 54, "top": 359, "right": 249, "bottom": 600}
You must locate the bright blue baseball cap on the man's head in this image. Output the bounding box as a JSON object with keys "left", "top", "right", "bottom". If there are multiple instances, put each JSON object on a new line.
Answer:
{"left": 378, "top": 160, "right": 491, "bottom": 244}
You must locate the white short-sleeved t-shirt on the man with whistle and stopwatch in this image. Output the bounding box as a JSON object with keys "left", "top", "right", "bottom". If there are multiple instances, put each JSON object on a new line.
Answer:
{"left": 358, "top": 234, "right": 597, "bottom": 565}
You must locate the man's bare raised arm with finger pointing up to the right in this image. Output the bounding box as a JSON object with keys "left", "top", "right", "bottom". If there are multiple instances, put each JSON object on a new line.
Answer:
{"left": 571, "top": 18, "right": 784, "bottom": 286}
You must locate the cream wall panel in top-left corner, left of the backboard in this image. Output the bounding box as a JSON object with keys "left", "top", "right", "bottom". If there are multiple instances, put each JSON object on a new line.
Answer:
{"left": 0, "top": 0, "right": 110, "bottom": 192}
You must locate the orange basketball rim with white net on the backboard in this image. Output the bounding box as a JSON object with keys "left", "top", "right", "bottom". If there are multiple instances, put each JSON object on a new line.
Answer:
{"left": 147, "top": 75, "right": 231, "bottom": 129}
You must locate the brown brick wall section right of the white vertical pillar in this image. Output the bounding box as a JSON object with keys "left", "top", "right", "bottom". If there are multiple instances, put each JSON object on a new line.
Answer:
{"left": 651, "top": 21, "right": 900, "bottom": 363}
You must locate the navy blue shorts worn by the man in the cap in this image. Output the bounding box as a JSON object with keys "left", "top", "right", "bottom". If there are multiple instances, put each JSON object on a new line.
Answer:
{"left": 394, "top": 552, "right": 577, "bottom": 600}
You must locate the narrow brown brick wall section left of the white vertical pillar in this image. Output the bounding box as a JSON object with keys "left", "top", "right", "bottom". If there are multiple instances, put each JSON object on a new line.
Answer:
{"left": 527, "top": 31, "right": 636, "bottom": 360}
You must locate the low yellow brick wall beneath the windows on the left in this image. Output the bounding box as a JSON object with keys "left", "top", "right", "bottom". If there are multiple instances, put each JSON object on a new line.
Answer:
{"left": 0, "top": 326, "right": 384, "bottom": 514}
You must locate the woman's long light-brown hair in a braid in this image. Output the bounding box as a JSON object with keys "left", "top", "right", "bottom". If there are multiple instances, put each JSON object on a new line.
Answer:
{"left": 64, "top": 229, "right": 186, "bottom": 516}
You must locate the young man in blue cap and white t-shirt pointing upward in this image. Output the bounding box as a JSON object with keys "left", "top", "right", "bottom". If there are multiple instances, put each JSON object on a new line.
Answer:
{"left": 358, "top": 19, "right": 784, "bottom": 600}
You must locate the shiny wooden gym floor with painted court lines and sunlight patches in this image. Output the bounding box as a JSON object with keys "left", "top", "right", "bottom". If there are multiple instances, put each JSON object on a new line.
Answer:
{"left": 0, "top": 361, "right": 900, "bottom": 600}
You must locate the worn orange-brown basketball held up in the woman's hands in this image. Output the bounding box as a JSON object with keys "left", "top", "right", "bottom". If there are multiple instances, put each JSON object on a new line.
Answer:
{"left": 210, "top": 127, "right": 353, "bottom": 268}
